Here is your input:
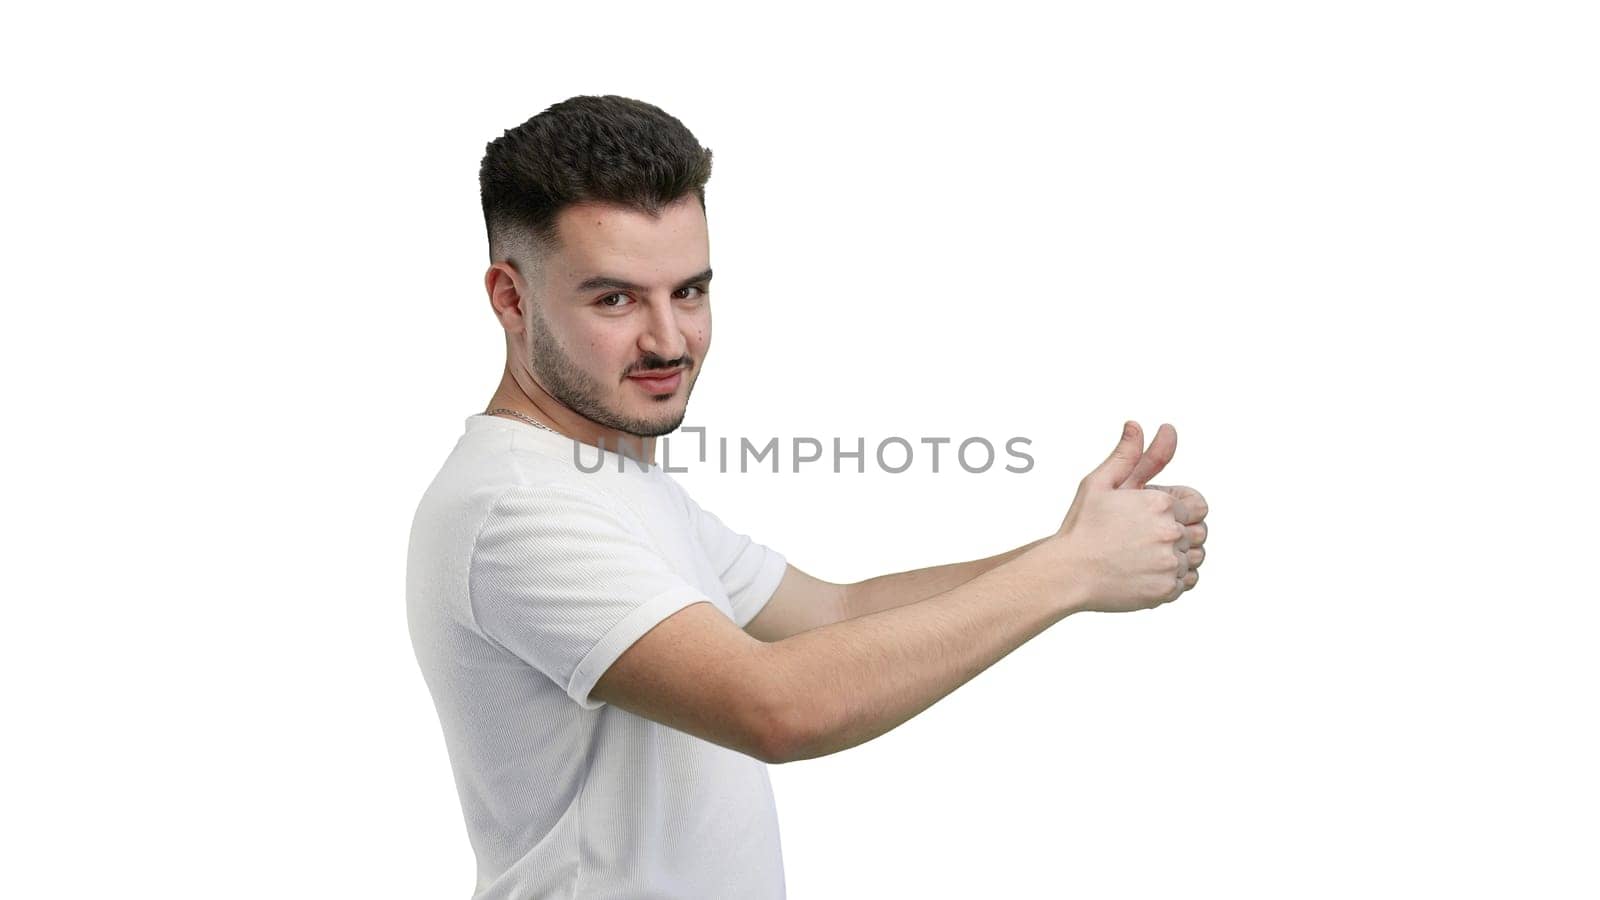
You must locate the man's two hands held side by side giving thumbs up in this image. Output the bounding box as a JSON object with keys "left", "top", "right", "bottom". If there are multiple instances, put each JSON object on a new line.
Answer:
{"left": 1056, "top": 421, "right": 1208, "bottom": 612}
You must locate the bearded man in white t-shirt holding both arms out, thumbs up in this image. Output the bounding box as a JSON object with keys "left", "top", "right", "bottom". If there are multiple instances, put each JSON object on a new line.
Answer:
{"left": 406, "top": 96, "right": 1206, "bottom": 900}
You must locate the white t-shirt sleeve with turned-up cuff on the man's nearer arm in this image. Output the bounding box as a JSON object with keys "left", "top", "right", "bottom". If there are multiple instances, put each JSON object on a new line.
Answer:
{"left": 469, "top": 485, "right": 707, "bottom": 709}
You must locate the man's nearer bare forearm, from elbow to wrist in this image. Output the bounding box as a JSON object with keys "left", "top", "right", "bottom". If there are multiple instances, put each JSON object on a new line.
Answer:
{"left": 763, "top": 534, "right": 1080, "bottom": 761}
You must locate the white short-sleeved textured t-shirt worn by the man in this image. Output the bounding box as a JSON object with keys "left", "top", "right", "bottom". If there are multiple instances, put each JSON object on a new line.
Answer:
{"left": 406, "top": 415, "right": 787, "bottom": 900}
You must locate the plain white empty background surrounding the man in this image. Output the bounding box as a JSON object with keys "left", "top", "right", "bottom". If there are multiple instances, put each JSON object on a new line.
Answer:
{"left": 0, "top": 2, "right": 1600, "bottom": 900}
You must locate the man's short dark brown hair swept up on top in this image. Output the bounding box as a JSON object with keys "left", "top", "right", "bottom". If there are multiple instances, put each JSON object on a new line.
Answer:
{"left": 478, "top": 94, "right": 710, "bottom": 263}
